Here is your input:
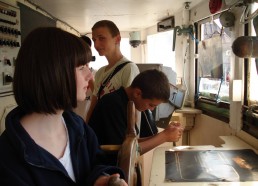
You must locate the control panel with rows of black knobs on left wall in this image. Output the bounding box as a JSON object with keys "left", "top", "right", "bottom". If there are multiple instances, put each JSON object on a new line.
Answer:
{"left": 0, "top": 1, "right": 21, "bottom": 97}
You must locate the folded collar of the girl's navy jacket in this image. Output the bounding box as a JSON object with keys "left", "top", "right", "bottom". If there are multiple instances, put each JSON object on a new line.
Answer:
{"left": 6, "top": 107, "right": 84, "bottom": 175}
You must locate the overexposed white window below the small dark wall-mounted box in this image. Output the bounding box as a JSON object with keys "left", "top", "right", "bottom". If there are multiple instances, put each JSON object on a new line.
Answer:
{"left": 147, "top": 30, "right": 175, "bottom": 71}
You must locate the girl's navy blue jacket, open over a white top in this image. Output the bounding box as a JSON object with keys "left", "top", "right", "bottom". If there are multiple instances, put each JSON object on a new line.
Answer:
{"left": 0, "top": 107, "right": 123, "bottom": 186}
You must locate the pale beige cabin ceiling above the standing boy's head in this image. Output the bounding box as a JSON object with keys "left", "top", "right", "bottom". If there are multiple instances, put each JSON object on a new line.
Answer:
{"left": 32, "top": 0, "right": 203, "bottom": 34}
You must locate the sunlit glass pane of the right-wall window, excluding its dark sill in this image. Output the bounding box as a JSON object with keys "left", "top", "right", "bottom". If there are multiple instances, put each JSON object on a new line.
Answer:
{"left": 198, "top": 19, "right": 232, "bottom": 102}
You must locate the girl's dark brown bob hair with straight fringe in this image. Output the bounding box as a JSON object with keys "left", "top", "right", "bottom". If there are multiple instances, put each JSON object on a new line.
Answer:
{"left": 13, "top": 27, "right": 91, "bottom": 114}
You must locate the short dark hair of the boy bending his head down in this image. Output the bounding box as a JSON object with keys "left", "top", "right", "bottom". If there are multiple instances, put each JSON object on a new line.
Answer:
{"left": 131, "top": 69, "right": 170, "bottom": 102}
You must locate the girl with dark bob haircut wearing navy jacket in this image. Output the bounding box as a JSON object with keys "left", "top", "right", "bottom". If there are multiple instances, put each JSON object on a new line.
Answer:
{"left": 0, "top": 27, "right": 127, "bottom": 186}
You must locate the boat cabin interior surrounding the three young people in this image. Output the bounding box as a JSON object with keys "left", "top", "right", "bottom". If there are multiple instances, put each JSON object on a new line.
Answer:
{"left": 0, "top": 0, "right": 258, "bottom": 186}
